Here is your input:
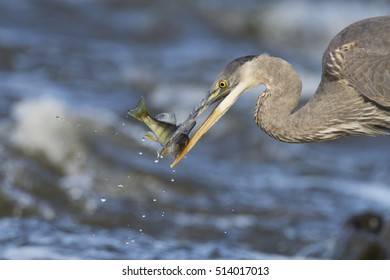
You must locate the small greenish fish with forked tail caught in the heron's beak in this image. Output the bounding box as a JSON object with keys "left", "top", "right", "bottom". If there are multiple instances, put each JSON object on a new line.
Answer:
{"left": 128, "top": 97, "right": 196, "bottom": 158}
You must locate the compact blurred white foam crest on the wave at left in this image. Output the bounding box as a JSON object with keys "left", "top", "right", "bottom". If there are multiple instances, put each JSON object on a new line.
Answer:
{"left": 11, "top": 97, "right": 84, "bottom": 173}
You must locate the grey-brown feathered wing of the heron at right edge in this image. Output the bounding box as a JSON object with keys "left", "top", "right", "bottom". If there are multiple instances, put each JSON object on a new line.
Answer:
{"left": 322, "top": 16, "right": 390, "bottom": 108}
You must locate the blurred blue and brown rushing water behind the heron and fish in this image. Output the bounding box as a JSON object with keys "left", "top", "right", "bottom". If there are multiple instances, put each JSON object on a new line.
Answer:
{"left": 0, "top": 0, "right": 390, "bottom": 259}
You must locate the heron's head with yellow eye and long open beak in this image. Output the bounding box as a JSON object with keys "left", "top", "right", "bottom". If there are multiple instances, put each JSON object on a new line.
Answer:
{"left": 171, "top": 55, "right": 258, "bottom": 167}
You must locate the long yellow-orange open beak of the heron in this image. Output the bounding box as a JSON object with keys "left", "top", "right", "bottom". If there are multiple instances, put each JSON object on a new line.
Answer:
{"left": 171, "top": 84, "right": 243, "bottom": 168}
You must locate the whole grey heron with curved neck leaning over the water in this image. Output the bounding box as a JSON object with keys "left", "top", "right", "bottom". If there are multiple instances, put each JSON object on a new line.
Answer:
{"left": 171, "top": 16, "right": 390, "bottom": 166}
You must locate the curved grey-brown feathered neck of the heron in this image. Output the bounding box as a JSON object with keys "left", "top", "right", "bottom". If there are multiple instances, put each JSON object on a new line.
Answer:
{"left": 254, "top": 56, "right": 329, "bottom": 143}
